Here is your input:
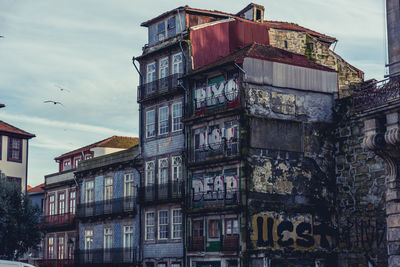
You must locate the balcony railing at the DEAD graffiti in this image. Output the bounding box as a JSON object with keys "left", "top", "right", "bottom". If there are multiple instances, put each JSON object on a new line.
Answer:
{"left": 191, "top": 189, "right": 239, "bottom": 208}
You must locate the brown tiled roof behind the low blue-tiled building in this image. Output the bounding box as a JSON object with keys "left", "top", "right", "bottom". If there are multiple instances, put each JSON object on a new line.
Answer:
{"left": 55, "top": 135, "right": 139, "bottom": 160}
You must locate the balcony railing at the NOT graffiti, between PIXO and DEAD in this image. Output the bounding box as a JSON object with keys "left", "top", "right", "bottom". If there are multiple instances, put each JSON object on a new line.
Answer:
{"left": 192, "top": 139, "right": 239, "bottom": 161}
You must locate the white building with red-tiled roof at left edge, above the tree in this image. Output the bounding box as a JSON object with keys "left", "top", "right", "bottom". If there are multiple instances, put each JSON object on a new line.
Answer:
{"left": 0, "top": 121, "right": 35, "bottom": 192}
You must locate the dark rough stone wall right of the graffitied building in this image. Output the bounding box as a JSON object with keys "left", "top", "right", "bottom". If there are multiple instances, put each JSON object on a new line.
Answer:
{"left": 335, "top": 97, "right": 387, "bottom": 267}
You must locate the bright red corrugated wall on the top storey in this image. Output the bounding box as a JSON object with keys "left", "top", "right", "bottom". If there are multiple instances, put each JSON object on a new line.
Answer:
{"left": 190, "top": 20, "right": 269, "bottom": 69}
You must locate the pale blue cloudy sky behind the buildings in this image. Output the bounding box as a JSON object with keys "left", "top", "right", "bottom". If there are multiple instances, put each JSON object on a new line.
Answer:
{"left": 0, "top": 0, "right": 386, "bottom": 186}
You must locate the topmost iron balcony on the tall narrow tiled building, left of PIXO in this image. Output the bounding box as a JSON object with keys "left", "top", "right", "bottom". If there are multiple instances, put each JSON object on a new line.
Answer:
{"left": 138, "top": 73, "right": 183, "bottom": 103}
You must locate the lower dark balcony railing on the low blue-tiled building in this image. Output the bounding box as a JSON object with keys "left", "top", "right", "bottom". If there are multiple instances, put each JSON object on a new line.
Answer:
{"left": 75, "top": 247, "right": 135, "bottom": 266}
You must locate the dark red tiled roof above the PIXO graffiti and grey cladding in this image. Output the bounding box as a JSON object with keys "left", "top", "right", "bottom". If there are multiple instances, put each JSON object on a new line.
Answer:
{"left": 187, "top": 43, "right": 336, "bottom": 76}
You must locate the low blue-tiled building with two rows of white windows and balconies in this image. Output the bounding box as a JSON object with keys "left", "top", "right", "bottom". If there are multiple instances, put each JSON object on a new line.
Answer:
{"left": 75, "top": 145, "right": 139, "bottom": 266}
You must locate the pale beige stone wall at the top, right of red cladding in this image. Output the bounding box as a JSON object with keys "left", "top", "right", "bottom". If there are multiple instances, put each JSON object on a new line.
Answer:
{"left": 269, "top": 29, "right": 363, "bottom": 97}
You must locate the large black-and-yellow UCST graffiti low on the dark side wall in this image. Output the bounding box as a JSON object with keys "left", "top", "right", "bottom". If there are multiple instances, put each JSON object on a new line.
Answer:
{"left": 250, "top": 214, "right": 335, "bottom": 250}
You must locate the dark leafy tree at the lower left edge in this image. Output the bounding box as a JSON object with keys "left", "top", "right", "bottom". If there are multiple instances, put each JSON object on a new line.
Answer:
{"left": 0, "top": 179, "right": 41, "bottom": 260}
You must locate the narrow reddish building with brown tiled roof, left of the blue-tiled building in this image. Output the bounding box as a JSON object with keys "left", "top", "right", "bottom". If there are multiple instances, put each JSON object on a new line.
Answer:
{"left": 38, "top": 136, "right": 138, "bottom": 266}
